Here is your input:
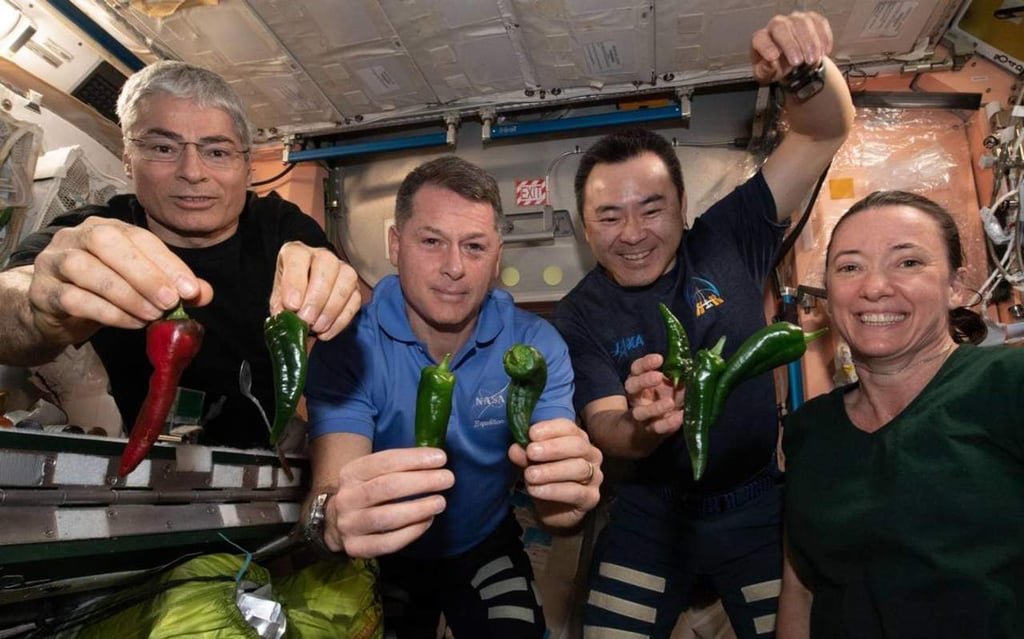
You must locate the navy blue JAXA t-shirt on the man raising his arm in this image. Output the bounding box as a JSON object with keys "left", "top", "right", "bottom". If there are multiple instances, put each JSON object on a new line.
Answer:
{"left": 552, "top": 172, "right": 786, "bottom": 494}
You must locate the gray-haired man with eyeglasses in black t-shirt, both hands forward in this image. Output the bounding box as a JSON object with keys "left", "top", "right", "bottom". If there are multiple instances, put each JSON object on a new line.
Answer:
{"left": 0, "top": 61, "right": 360, "bottom": 448}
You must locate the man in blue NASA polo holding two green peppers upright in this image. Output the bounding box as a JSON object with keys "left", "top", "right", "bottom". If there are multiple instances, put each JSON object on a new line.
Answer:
{"left": 306, "top": 157, "right": 602, "bottom": 639}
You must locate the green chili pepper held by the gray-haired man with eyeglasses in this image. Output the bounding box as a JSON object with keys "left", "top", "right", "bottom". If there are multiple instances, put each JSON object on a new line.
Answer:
{"left": 263, "top": 310, "right": 309, "bottom": 445}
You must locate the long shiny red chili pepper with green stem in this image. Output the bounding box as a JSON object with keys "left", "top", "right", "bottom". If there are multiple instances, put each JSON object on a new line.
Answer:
{"left": 118, "top": 304, "right": 203, "bottom": 477}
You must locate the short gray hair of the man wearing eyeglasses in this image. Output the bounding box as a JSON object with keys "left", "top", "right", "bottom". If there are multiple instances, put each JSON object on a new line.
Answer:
{"left": 117, "top": 60, "right": 252, "bottom": 150}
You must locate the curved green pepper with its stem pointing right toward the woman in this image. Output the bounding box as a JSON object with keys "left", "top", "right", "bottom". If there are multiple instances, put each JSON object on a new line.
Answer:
{"left": 714, "top": 322, "right": 828, "bottom": 420}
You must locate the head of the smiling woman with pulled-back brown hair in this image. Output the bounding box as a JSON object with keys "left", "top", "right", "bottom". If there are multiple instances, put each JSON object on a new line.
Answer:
{"left": 825, "top": 193, "right": 967, "bottom": 389}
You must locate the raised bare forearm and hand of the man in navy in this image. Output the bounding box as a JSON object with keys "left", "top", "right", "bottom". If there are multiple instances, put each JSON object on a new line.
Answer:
{"left": 751, "top": 11, "right": 854, "bottom": 220}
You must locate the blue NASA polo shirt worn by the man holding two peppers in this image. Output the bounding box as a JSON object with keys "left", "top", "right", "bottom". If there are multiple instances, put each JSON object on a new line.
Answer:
{"left": 306, "top": 275, "right": 575, "bottom": 558}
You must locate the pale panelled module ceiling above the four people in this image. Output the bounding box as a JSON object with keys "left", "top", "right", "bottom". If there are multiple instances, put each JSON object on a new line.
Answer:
{"left": 68, "top": 0, "right": 959, "bottom": 139}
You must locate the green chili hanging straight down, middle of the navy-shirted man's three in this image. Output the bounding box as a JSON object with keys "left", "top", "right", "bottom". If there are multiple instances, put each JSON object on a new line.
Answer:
{"left": 683, "top": 336, "right": 725, "bottom": 481}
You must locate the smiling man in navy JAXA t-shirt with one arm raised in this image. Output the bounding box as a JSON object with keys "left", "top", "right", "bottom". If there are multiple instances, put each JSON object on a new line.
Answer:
{"left": 553, "top": 9, "right": 853, "bottom": 638}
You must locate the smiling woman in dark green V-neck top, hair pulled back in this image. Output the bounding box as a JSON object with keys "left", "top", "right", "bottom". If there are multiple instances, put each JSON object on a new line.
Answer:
{"left": 778, "top": 191, "right": 1024, "bottom": 639}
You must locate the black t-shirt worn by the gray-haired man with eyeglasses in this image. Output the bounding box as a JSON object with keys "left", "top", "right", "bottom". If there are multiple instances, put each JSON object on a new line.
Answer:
{"left": 7, "top": 193, "right": 330, "bottom": 448}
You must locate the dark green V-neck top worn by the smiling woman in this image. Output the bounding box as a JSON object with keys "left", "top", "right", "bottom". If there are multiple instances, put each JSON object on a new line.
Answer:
{"left": 784, "top": 345, "right": 1024, "bottom": 639}
